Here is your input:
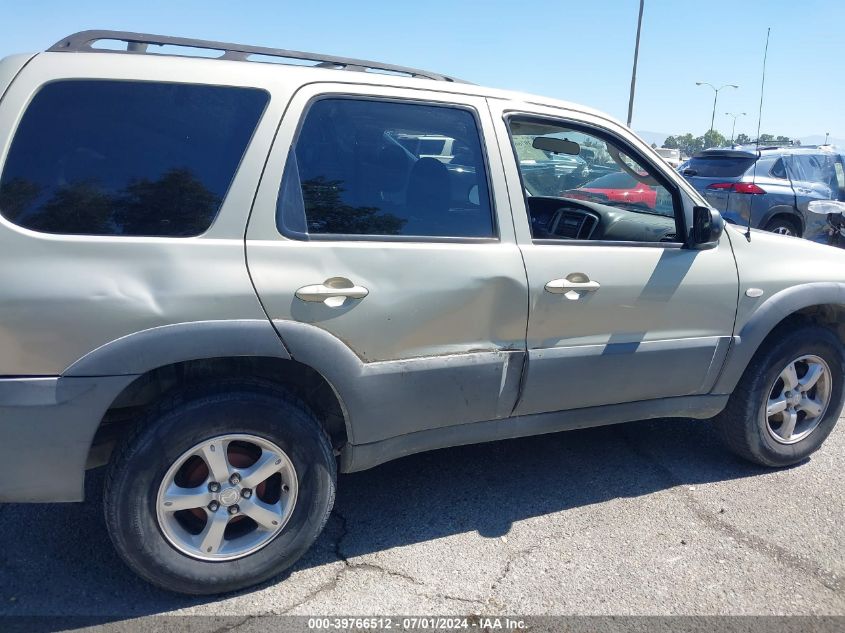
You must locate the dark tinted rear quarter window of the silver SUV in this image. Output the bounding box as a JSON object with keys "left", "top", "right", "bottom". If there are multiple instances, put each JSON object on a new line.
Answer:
{"left": 0, "top": 80, "right": 269, "bottom": 237}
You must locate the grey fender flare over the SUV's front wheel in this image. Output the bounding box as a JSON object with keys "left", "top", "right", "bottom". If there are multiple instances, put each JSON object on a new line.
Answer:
{"left": 712, "top": 282, "right": 845, "bottom": 394}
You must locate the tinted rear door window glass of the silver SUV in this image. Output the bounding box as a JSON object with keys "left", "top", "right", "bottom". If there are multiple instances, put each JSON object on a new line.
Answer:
{"left": 277, "top": 97, "right": 496, "bottom": 239}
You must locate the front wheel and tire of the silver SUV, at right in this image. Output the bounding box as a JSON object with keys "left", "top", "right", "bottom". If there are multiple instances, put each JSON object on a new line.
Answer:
{"left": 716, "top": 325, "right": 845, "bottom": 467}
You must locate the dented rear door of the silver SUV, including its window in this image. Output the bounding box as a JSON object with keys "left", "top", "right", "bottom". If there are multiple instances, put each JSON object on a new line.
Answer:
{"left": 242, "top": 84, "right": 528, "bottom": 443}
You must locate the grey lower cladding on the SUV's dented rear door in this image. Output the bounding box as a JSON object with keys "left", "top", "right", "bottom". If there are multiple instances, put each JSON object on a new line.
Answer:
{"left": 273, "top": 320, "right": 525, "bottom": 444}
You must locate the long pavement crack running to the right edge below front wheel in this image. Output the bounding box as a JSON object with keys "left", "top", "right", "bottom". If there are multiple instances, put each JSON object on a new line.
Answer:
{"left": 621, "top": 430, "right": 845, "bottom": 593}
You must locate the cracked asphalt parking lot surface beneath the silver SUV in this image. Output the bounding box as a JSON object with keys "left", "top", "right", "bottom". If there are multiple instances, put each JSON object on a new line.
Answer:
{"left": 0, "top": 412, "right": 845, "bottom": 621}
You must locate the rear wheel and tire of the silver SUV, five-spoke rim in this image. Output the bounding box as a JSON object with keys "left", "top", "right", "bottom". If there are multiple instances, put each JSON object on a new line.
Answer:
{"left": 104, "top": 383, "right": 337, "bottom": 595}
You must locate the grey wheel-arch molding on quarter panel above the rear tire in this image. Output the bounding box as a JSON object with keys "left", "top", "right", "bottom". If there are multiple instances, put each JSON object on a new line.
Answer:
{"left": 62, "top": 319, "right": 290, "bottom": 376}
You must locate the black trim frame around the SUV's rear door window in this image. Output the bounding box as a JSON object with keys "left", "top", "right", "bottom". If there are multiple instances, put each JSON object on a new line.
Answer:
{"left": 274, "top": 92, "right": 502, "bottom": 244}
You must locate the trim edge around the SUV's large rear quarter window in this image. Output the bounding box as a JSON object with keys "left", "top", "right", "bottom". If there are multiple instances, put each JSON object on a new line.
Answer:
{"left": 0, "top": 76, "right": 273, "bottom": 241}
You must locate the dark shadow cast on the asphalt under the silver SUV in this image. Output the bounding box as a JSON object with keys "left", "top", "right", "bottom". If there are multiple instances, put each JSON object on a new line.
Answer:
{"left": 0, "top": 420, "right": 780, "bottom": 620}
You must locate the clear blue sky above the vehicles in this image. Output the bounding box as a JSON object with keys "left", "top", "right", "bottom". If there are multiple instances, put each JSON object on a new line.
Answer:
{"left": 0, "top": 0, "right": 845, "bottom": 139}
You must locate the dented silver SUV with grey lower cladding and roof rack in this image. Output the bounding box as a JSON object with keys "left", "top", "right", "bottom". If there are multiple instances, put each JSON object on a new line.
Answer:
{"left": 0, "top": 32, "right": 845, "bottom": 594}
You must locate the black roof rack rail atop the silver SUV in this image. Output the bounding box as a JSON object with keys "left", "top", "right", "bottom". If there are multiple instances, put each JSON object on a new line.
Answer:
{"left": 47, "top": 31, "right": 467, "bottom": 83}
